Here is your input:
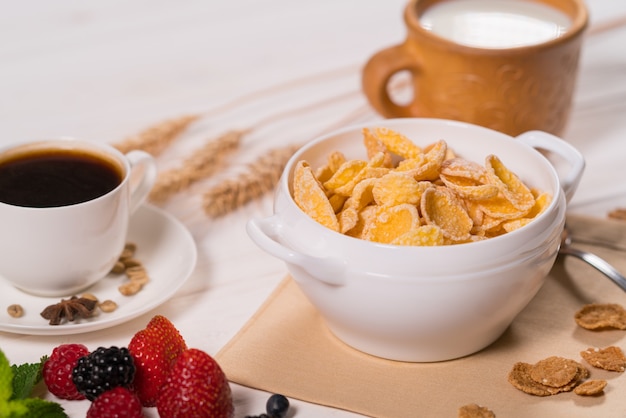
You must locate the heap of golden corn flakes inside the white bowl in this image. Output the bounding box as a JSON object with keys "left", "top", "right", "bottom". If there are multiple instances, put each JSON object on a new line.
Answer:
{"left": 292, "top": 128, "right": 552, "bottom": 246}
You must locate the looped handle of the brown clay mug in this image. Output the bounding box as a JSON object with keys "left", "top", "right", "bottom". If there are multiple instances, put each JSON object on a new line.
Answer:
{"left": 361, "top": 42, "right": 422, "bottom": 117}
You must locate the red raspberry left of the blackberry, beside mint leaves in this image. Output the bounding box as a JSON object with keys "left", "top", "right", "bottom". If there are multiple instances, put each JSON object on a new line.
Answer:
{"left": 42, "top": 344, "right": 89, "bottom": 400}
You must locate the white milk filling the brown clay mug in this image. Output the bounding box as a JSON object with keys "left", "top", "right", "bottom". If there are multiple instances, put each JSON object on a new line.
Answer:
{"left": 420, "top": 0, "right": 571, "bottom": 48}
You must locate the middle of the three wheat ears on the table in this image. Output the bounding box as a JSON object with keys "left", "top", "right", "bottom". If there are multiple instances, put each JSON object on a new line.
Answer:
{"left": 150, "top": 130, "right": 247, "bottom": 202}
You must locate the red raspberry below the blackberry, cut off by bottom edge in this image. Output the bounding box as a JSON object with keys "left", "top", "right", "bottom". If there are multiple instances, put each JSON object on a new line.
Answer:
{"left": 87, "top": 386, "right": 144, "bottom": 418}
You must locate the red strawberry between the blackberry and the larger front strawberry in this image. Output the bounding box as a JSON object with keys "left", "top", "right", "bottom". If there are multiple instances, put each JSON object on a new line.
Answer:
{"left": 128, "top": 315, "right": 187, "bottom": 406}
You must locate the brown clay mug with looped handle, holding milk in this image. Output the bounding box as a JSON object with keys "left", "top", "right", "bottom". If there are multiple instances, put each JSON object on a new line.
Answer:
{"left": 362, "top": 0, "right": 588, "bottom": 136}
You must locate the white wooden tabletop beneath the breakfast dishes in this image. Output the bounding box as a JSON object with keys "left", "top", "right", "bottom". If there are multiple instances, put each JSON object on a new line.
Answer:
{"left": 0, "top": 0, "right": 626, "bottom": 417}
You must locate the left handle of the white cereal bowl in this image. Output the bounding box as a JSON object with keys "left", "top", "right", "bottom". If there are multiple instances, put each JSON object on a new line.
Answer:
{"left": 246, "top": 216, "right": 346, "bottom": 285}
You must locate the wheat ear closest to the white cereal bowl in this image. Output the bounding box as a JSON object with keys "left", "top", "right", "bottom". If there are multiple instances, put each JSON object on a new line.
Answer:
{"left": 202, "top": 145, "right": 299, "bottom": 218}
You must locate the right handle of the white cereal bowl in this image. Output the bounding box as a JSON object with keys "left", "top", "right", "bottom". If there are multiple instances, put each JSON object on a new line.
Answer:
{"left": 515, "top": 131, "right": 585, "bottom": 203}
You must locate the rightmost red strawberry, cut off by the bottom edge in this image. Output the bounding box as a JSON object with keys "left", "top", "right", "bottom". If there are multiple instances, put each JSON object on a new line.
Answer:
{"left": 157, "top": 348, "right": 234, "bottom": 418}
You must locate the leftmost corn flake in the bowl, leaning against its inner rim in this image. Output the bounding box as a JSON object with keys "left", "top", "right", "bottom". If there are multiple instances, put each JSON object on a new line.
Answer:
{"left": 293, "top": 161, "right": 339, "bottom": 231}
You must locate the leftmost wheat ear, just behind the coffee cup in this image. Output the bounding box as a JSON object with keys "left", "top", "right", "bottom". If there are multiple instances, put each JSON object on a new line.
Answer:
{"left": 113, "top": 114, "right": 200, "bottom": 156}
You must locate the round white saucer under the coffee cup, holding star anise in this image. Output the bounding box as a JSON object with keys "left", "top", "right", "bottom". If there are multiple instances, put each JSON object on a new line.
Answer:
{"left": 0, "top": 205, "right": 197, "bottom": 335}
